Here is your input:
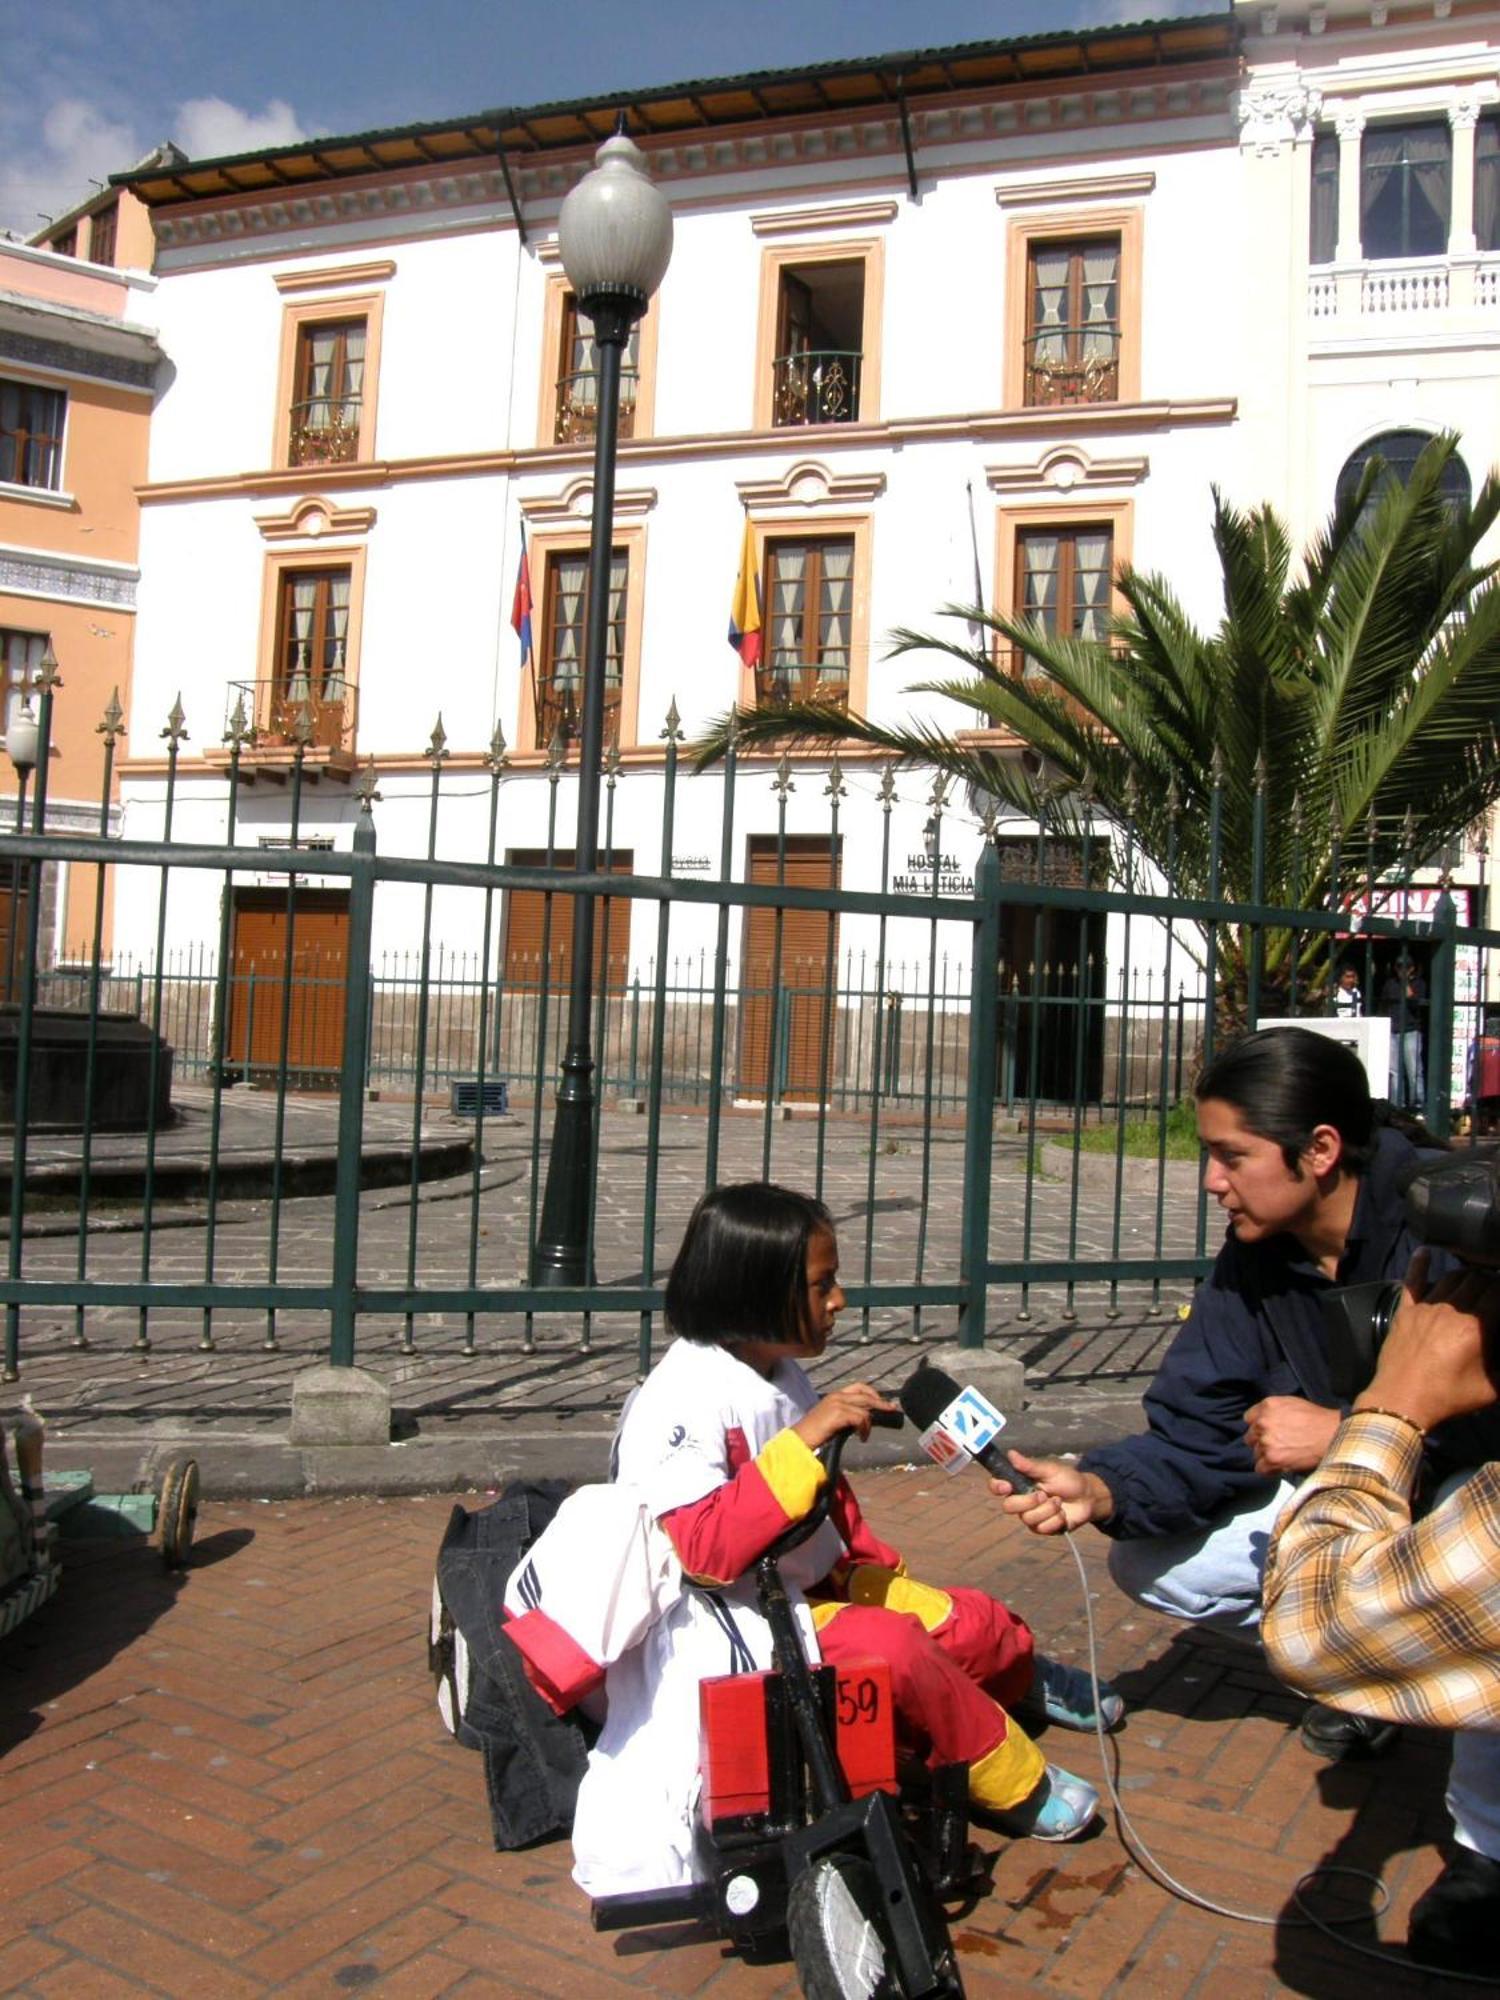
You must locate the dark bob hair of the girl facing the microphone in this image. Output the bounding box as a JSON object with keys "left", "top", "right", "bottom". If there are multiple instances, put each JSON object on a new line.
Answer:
{"left": 666, "top": 1180, "right": 834, "bottom": 1346}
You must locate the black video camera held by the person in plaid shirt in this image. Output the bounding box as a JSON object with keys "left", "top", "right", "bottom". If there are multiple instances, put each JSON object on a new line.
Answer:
{"left": 1324, "top": 1148, "right": 1500, "bottom": 1402}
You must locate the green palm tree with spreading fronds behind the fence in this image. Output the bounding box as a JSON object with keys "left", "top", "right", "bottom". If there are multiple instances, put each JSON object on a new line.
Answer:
{"left": 696, "top": 436, "right": 1500, "bottom": 1008}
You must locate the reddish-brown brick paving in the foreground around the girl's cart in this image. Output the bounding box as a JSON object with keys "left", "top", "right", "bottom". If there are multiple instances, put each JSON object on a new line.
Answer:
{"left": 0, "top": 1470, "right": 1452, "bottom": 2000}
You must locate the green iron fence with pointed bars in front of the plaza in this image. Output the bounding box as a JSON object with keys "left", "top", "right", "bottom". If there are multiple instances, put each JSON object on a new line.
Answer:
{"left": 0, "top": 668, "right": 1500, "bottom": 1378}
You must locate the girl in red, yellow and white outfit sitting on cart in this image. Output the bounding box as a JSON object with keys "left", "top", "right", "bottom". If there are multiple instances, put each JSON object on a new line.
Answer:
{"left": 574, "top": 1182, "right": 1124, "bottom": 1896}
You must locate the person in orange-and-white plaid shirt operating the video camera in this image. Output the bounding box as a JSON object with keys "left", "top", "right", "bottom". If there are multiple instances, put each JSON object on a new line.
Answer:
{"left": 1260, "top": 1252, "right": 1500, "bottom": 1974}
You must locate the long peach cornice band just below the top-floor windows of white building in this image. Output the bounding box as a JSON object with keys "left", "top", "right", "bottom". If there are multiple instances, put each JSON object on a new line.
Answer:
{"left": 136, "top": 396, "right": 1240, "bottom": 506}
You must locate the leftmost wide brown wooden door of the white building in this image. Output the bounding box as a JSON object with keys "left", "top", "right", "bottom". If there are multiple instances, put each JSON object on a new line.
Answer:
{"left": 224, "top": 888, "right": 348, "bottom": 1090}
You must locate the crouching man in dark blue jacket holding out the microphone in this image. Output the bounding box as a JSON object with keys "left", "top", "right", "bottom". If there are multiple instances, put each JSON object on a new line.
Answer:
{"left": 996, "top": 1028, "right": 1500, "bottom": 1950}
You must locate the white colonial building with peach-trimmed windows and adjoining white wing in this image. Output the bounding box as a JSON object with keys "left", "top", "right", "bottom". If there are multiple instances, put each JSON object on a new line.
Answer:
{"left": 106, "top": 0, "right": 1500, "bottom": 1090}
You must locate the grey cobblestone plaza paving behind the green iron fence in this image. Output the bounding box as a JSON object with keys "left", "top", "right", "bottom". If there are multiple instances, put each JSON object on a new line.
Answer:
{"left": 0, "top": 1092, "right": 1216, "bottom": 1492}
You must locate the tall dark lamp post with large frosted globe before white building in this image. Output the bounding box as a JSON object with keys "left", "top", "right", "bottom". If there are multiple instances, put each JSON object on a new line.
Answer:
{"left": 532, "top": 132, "right": 672, "bottom": 1286}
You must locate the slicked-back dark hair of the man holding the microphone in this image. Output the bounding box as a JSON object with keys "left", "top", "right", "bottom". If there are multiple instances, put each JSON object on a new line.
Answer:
{"left": 1192, "top": 1028, "right": 1376, "bottom": 1174}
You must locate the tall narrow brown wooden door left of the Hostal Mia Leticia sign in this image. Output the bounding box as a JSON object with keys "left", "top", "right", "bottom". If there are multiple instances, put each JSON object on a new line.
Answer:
{"left": 736, "top": 834, "right": 838, "bottom": 1104}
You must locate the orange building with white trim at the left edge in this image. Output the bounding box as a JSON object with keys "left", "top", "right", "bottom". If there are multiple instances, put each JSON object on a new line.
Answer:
{"left": 0, "top": 223, "right": 162, "bottom": 966}
